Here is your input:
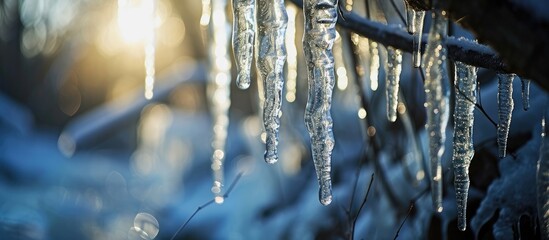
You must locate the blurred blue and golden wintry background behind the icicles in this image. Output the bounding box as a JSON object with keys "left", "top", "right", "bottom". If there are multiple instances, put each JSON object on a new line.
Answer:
{"left": 0, "top": 0, "right": 546, "bottom": 239}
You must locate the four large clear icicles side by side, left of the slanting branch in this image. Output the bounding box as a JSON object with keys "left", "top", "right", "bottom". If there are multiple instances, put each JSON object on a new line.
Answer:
{"left": 197, "top": 0, "right": 337, "bottom": 205}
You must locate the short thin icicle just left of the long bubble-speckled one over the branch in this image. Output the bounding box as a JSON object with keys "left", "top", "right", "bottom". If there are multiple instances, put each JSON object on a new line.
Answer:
{"left": 404, "top": 1, "right": 425, "bottom": 68}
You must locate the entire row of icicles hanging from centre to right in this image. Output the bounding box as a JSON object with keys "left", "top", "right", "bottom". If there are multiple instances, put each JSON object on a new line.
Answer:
{"left": 193, "top": 0, "right": 529, "bottom": 215}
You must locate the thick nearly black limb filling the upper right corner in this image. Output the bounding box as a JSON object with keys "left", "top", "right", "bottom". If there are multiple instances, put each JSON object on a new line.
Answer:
{"left": 407, "top": 0, "right": 549, "bottom": 90}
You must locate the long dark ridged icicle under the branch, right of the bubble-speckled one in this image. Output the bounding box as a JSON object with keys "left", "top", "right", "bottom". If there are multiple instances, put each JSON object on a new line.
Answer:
{"left": 452, "top": 62, "right": 477, "bottom": 231}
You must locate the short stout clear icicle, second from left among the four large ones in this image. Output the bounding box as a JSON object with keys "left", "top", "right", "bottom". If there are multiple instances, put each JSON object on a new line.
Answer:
{"left": 233, "top": 0, "right": 255, "bottom": 89}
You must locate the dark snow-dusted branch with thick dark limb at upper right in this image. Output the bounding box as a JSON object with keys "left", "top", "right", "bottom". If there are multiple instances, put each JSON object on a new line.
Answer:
{"left": 291, "top": 0, "right": 549, "bottom": 90}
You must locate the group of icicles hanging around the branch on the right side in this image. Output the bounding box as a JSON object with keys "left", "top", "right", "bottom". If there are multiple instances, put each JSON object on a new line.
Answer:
{"left": 414, "top": 4, "right": 529, "bottom": 231}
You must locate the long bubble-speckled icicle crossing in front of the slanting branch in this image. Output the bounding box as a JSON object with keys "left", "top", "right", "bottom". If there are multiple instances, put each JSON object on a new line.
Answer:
{"left": 423, "top": 10, "right": 449, "bottom": 212}
